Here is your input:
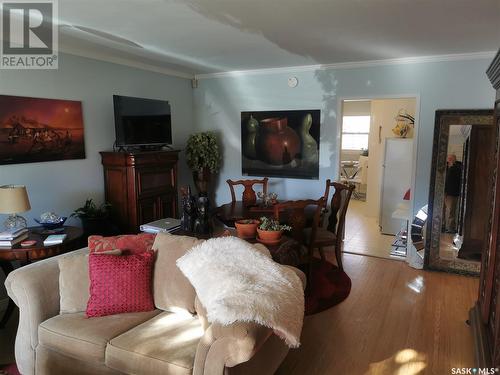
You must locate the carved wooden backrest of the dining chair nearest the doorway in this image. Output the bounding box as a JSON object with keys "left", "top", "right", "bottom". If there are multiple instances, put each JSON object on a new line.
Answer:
{"left": 323, "top": 179, "right": 355, "bottom": 239}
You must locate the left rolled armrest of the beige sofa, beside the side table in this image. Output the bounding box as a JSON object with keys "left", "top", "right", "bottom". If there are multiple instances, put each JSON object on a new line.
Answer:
{"left": 5, "top": 248, "right": 88, "bottom": 374}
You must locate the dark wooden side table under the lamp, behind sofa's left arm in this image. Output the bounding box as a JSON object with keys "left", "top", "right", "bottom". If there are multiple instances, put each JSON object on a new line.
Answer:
{"left": 0, "top": 226, "right": 83, "bottom": 329}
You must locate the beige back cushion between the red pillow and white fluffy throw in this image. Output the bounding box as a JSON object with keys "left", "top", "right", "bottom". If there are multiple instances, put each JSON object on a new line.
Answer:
{"left": 153, "top": 233, "right": 203, "bottom": 313}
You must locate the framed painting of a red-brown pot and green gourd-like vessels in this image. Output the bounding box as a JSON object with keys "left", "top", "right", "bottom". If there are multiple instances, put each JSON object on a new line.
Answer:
{"left": 241, "top": 109, "right": 321, "bottom": 180}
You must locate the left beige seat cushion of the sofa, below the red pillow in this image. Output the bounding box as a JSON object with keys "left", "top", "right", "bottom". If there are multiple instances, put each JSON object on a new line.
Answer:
{"left": 38, "top": 310, "right": 159, "bottom": 363}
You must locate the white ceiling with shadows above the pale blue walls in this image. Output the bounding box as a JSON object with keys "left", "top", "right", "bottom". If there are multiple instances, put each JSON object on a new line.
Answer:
{"left": 59, "top": 0, "right": 500, "bottom": 76}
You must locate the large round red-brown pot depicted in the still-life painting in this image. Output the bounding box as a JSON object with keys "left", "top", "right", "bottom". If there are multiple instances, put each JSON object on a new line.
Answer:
{"left": 256, "top": 118, "right": 300, "bottom": 165}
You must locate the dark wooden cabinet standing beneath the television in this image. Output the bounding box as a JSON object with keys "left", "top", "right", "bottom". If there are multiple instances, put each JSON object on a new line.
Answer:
{"left": 101, "top": 151, "right": 179, "bottom": 233}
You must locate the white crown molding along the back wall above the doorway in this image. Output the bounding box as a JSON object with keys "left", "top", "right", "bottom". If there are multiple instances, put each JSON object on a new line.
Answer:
{"left": 195, "top": 51, "right": 495, "bottom": 79}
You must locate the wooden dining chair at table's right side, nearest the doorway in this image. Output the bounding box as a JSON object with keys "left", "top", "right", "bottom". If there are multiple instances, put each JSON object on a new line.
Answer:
{"left": 306, "top": 180, "right": 355, "bottom": 270}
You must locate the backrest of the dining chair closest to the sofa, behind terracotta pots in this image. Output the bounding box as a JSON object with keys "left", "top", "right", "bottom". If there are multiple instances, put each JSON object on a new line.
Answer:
{"left": 273, "top": 197, "right": 324, "bottom": 244}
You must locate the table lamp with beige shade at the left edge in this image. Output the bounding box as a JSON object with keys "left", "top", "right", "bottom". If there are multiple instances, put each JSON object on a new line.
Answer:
{"left": 0, "top": 185, "right": 31, "bottom": 229}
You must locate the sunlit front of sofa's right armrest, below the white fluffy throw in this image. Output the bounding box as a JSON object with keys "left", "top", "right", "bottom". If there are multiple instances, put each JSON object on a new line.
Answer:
{"left": 193, "top": 322, "right": 273, "bottom": 375}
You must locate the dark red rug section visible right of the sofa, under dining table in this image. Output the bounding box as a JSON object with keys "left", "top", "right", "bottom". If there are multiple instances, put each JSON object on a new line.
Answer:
{"left": 305, "top": 259, "right": 351, "bottom": 315}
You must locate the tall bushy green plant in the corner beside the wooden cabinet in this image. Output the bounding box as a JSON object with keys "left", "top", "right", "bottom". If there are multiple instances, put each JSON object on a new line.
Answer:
{"left": 186, "top": 132, "right": 220, "bottom": 196}
